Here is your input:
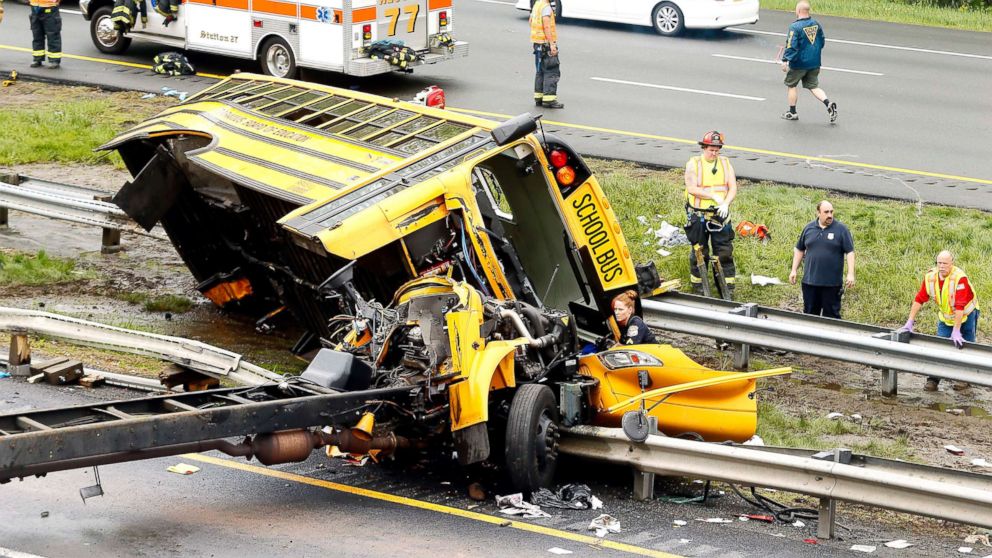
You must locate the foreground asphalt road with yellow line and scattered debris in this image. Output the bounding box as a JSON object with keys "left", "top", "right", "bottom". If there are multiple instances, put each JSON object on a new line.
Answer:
{"left": 0, "top": 378, "right": 960, "bottom": 558}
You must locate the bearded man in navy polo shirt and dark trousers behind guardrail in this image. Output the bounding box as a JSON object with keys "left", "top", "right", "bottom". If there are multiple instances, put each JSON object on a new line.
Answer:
{"left": 789, "top": 200, "right": 854, "bottom": 319}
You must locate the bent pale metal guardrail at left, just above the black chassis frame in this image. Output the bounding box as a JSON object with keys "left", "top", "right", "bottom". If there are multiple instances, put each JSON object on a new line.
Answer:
{"left": 0, "top": 307, "right": 283, "bottom": 385}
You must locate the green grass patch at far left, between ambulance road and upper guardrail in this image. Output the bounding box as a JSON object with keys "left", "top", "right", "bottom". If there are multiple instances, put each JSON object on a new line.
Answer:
{"left": 0, "top": 81, "right": 175, "bottom": 168}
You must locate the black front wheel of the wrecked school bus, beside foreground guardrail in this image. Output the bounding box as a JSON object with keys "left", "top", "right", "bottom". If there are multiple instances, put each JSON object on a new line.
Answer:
{"left": 506, "top": 384, "right": 560, "bottom": 493}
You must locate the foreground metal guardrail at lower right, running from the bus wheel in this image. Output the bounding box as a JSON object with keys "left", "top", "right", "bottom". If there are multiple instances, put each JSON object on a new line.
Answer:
{"left": 559, "top": 426, "right": 992, "bottom": 537}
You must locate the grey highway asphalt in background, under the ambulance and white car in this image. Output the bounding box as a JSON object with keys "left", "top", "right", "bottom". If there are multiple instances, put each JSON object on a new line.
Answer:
{"left": 0, "top": 0, "right": 992, "bottom": 210}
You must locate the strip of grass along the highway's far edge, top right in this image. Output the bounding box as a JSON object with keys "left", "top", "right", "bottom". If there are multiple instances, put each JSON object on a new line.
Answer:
{"left": 761, "top": 0, "right": 992, "bottom": 32}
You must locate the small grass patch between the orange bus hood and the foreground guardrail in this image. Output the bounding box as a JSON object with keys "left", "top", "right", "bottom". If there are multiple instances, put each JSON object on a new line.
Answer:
{"left": 758, "top": 402, "right": 914, "bottom": 461}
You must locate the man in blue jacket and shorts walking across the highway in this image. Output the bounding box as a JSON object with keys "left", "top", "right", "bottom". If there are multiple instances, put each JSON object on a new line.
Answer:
{"left": 782, "top": 0, "right": 837, "bottom": 123}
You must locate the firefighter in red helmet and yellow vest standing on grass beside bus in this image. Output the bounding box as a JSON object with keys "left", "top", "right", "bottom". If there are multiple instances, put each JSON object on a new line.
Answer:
{"left": 685, "top": 130, "right": 737, "bottom": 297}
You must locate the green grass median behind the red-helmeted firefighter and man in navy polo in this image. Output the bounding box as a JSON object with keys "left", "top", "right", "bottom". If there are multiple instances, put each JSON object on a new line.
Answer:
{"left": 589, "top": 159, "right": 992, "bottom": 341}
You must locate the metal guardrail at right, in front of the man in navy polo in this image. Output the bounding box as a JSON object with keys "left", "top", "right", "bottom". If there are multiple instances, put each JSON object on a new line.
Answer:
{"left": 642, "top": 294, "right": 992, "bottom": 394}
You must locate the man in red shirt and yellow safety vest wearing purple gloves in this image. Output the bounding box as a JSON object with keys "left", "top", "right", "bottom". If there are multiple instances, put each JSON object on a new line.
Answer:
{"left": 900, "top": 250, "right": 979, "bottom": 391}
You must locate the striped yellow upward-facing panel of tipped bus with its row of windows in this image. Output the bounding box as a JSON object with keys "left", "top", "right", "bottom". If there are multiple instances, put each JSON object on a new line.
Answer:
{"left": 101, "top": 73, "right": 497, "bottom": 210}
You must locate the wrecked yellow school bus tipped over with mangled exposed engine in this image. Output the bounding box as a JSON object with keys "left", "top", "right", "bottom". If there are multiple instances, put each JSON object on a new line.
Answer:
{"left": 0, "top": 74, "right": 787, "bottom": 490}
